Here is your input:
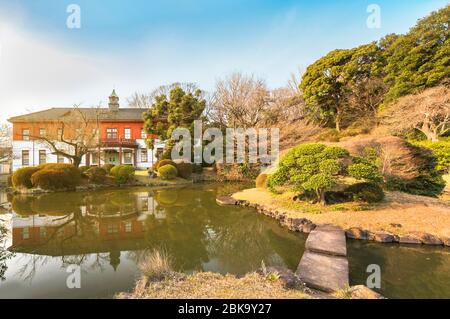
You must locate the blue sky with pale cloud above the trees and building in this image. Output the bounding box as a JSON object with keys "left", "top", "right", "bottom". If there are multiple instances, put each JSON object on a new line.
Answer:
{"left": 0, "top": 0, "right": 449, "bottom": 120}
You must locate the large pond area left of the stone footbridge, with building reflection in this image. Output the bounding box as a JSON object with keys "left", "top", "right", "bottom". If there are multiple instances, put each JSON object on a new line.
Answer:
{"left": 0, "top": 185, "right": 306, "bottom": 298}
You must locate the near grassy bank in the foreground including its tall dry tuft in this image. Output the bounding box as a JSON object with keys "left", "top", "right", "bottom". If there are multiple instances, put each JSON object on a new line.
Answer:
{"left": 116, "top": 249, "right": 309, "bottom": 299}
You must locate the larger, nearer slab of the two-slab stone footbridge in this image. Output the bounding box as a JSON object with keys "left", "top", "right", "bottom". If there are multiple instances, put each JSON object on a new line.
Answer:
{"left": 296, "top": 252, "right": 349, "bottom": 292}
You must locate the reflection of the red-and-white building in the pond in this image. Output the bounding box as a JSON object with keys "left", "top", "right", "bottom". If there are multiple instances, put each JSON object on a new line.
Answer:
{"left": 9, "top": 192, "right": 162, "bottom": 269}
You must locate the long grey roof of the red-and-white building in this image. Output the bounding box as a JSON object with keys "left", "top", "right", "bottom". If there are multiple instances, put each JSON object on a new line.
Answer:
{"left": 8, "top": 107, "right": 146, "bottom": 123}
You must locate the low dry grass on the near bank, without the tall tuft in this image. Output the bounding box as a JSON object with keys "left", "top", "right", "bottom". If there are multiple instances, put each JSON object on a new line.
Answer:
{"left": 117, "top": 272, "right": 310, "bottom": 299}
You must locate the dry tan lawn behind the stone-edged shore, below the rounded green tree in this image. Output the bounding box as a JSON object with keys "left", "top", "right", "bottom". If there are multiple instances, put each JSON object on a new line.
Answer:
{"left": 233, "top": 189, "right": 450, "bottom": 236}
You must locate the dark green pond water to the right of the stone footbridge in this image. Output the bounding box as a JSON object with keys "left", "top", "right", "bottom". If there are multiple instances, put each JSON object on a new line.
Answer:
{"left": 348, "top": 241, "right": 450, "bottom": 298}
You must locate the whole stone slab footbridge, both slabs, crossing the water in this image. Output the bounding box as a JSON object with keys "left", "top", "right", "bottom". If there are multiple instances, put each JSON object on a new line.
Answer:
{"left": 297, "top": 226, "right": 349, "bottom": 292}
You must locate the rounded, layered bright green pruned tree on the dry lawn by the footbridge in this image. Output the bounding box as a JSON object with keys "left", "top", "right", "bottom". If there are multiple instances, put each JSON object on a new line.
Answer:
{"left": 267, "top": 144, "right": 349, "bottom": 202}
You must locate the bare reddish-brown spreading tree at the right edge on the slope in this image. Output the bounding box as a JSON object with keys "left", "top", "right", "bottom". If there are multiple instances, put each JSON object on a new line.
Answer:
{"left": 383, "top": 86, "right": 450, "bottom": 142}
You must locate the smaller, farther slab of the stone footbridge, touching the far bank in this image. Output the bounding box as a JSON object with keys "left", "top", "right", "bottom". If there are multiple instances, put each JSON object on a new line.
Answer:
{"left": 306, "top": 226, "right": 347, "bottom": 257}
